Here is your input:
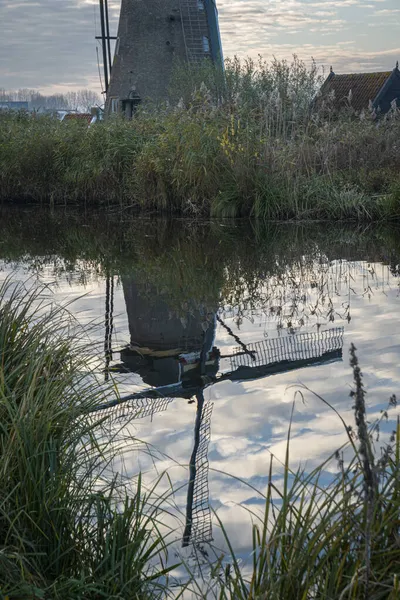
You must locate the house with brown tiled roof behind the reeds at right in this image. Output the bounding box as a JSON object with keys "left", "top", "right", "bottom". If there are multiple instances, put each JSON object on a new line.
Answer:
{"left": 315, "top": 62, "right": 400, "bottom": 114}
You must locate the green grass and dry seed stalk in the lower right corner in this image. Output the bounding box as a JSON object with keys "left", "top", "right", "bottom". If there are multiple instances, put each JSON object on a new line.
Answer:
{"left": 209, "top": 370, "right": 400, "bottom": 600}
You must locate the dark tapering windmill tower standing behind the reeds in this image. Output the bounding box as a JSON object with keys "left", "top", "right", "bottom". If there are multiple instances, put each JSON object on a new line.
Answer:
{"left": 106, "top": 0, "right": 222, "bottom": 117}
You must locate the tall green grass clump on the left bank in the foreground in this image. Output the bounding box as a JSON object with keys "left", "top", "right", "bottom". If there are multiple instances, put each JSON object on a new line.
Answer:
{"left": 0, "top": 281, "right": 177, "bottom": 600}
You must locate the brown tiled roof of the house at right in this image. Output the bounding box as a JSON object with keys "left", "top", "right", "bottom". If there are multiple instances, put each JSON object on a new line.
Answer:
{"left": 321, "top": 71, "right": 392, "bottom": 111}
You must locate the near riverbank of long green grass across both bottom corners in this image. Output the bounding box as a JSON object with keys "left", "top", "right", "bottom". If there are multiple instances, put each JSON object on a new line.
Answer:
{"left": 0, "top": 281, "right": 400, "bottom": 600}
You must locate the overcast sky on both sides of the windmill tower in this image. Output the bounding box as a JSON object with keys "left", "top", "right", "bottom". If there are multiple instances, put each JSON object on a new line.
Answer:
{"left": 0, "top": 0, "right": 400, "bottom": 93}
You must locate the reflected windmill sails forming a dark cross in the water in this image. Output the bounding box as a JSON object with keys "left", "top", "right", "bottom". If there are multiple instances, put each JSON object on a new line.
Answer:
{"left": 96, "top": 327, "right": 344, "bottom": 547}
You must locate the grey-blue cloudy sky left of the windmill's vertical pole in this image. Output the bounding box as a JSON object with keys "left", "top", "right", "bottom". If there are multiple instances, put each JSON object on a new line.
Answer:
{"left": 0, "top": 0, "right": 109, "bottom": 88}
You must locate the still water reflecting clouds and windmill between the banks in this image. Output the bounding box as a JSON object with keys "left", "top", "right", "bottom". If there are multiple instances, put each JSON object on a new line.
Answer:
{"left": 0, "top": 211, "right": 400, "bottom": 572}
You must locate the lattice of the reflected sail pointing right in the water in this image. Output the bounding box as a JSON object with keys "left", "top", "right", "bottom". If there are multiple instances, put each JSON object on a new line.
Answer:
{"left": 230, "top": 327, "right": 344, "bottom": 369}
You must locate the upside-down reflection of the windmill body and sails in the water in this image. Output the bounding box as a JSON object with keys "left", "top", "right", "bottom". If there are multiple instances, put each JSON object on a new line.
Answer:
{"left": 97, "top": 278, "right": 344, "bottom": 546}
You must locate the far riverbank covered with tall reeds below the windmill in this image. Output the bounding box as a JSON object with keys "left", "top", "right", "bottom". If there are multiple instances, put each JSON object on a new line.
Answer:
{"left": 0, "top": 59, "right": 400, "bottom": 220}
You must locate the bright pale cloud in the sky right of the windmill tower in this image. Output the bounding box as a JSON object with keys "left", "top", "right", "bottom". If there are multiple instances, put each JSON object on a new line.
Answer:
{"left": 219, "top": 0, "right": 399, "bottom": 72}
